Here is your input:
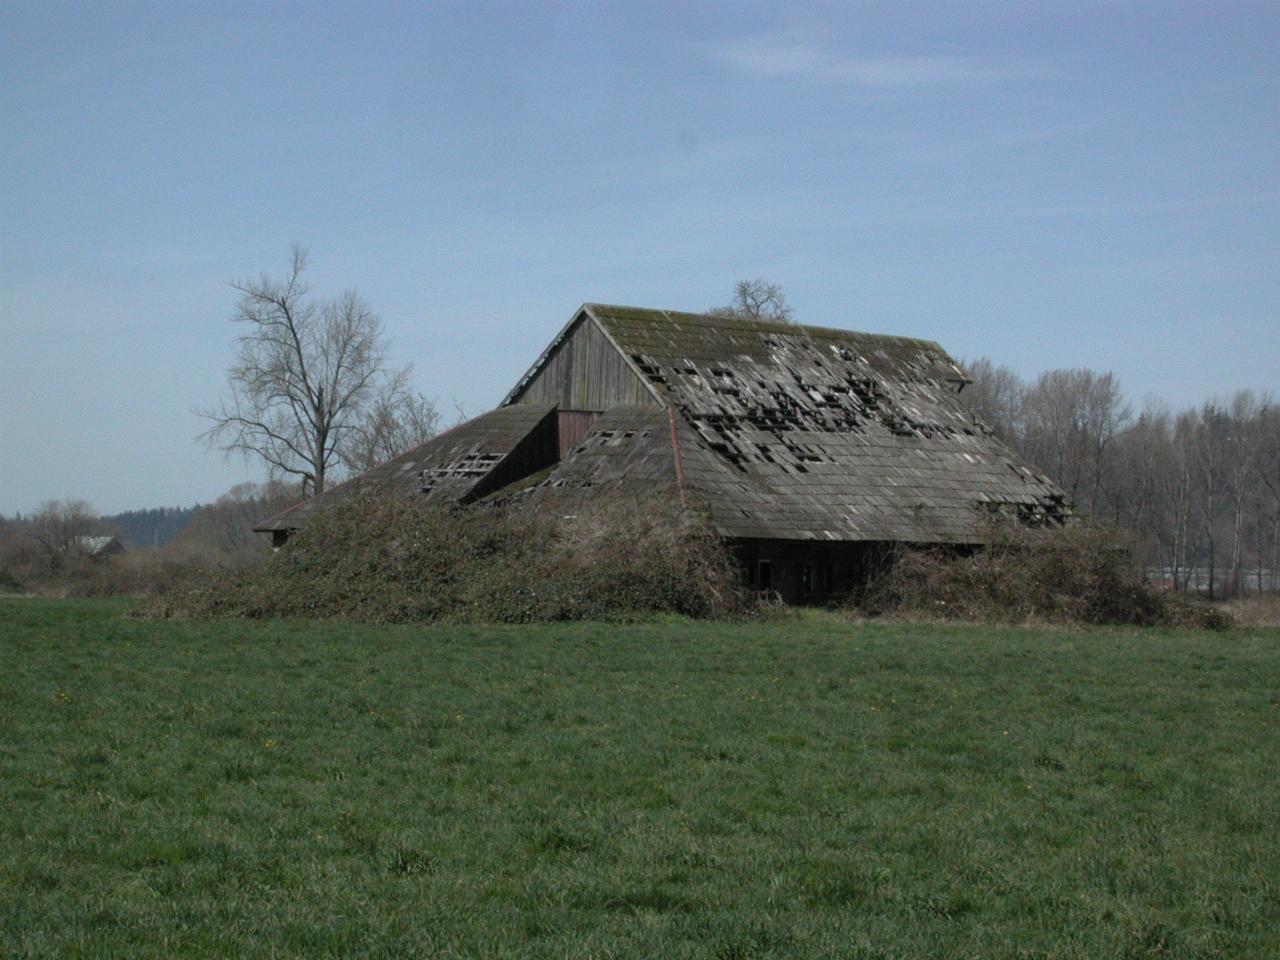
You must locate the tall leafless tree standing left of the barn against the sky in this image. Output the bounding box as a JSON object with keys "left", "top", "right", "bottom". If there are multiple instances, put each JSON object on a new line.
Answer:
{"left": 201, "top": 246, "right": 430, "bottom": 494}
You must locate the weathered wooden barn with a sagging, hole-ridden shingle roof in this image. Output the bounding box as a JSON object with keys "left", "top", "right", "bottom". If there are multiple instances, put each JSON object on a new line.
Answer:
{"left": 259, "top": 303, "right": 1069, "bottom": 600}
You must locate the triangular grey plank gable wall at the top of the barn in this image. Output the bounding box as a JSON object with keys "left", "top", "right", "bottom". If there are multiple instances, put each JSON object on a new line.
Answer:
{"left": 515, "top": 317, "right": 658, "bottom": 412}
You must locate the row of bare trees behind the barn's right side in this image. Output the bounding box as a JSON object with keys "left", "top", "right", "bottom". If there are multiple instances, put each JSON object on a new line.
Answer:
{"left": 961, "top": 357, "right": 1280, "bottom": 596}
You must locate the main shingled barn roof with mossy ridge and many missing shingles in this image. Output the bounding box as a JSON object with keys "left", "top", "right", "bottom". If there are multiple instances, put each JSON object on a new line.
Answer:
{"left": 517, "top": 303, "right": 1066, "bottom": 543}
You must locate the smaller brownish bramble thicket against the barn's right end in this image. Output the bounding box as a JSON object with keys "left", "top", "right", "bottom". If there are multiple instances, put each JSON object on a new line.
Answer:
{"left": 861, "top": 522, "right": 1231, "bottom": 628}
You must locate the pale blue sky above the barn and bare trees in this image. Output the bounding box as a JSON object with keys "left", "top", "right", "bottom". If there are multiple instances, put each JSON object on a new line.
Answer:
{"left": 0, "top": 0, "right": 1280, "bottom": 513}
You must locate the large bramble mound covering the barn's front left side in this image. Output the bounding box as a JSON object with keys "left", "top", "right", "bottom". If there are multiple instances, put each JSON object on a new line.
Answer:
{"left": 145, "top": 495, "right": 748, "bottom": 622}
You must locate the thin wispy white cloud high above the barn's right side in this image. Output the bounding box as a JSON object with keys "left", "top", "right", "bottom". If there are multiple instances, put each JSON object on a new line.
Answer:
{"left": 712, "top": 35, "right": 1020, "bottom": 91}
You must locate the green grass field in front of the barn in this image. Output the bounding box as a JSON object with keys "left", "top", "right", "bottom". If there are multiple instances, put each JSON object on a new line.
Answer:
{"left": 0, "top": 600, "right": 1280, "bottom": 960}
